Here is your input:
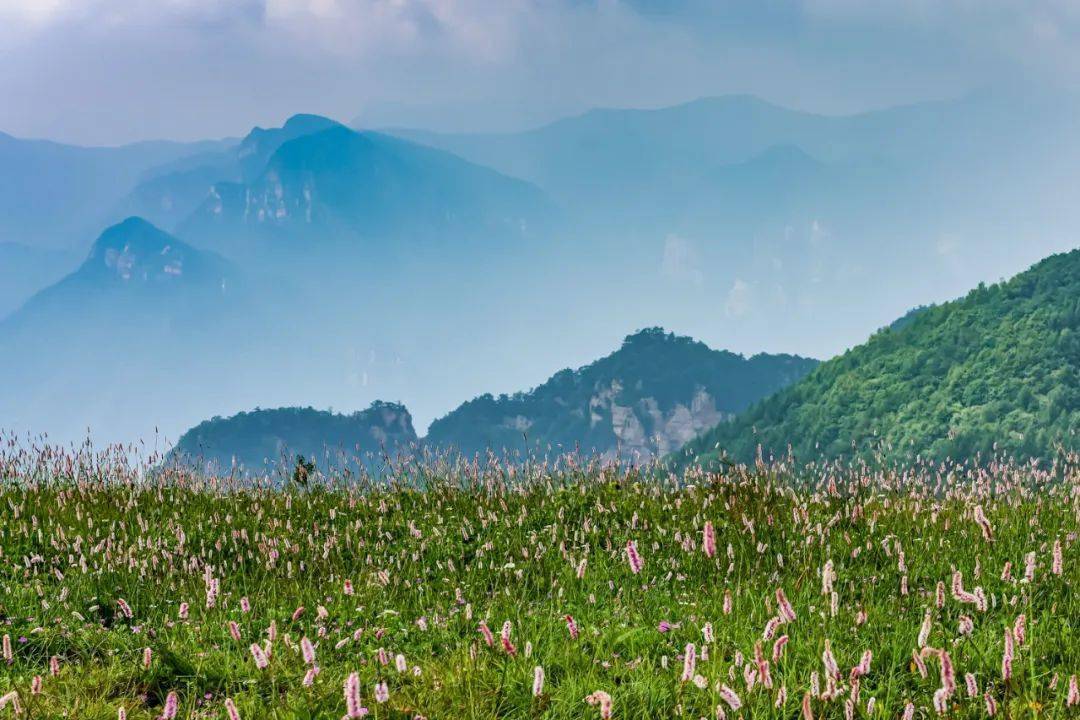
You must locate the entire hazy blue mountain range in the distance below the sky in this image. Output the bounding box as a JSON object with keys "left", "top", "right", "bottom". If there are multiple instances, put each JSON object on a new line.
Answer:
{"left": 0, "top": 93, "right": 1080, "bottom": 452}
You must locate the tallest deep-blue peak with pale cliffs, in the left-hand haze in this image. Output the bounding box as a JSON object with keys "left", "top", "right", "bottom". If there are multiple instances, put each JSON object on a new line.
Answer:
{"left": 179, "top": 124, "right": 551, "bottom": 267}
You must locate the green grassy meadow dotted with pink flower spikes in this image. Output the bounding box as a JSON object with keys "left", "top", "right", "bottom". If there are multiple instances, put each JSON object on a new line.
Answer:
{"left": 0, "top": 447, "right": 1080, "bottom": 720}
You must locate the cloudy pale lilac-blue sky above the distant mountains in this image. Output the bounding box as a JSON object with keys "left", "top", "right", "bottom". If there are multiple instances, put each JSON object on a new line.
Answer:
{"left": 0, "top": 0, "right": 1080, "bottom": 145}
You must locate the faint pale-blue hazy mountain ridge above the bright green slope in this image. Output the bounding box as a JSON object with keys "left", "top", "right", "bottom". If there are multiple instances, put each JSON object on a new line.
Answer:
{"left": 387, "top": 87, "right": 1080, "bottom": 367}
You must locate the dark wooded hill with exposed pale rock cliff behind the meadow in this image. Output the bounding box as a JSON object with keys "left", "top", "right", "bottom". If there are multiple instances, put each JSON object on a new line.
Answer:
{"left": 424, "top": 328, "right": 818, "bottom": 459}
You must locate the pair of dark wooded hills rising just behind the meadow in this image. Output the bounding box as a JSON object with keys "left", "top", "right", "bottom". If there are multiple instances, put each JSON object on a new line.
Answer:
{"left": 162, "top": 328, "right": 818, "bottom": 475}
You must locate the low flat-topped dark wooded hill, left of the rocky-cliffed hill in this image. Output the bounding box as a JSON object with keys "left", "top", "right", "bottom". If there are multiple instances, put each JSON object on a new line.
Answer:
{"left": 167, "top": 402, "right": 417, "bottom": 475}
